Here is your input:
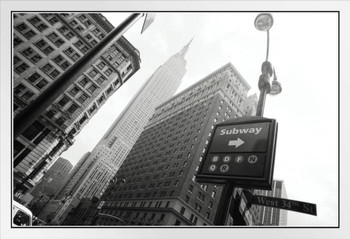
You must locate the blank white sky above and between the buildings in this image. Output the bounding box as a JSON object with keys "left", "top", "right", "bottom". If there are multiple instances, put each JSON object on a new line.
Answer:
{"left": 61, "top": 12, "right": 338, "bottom": 227}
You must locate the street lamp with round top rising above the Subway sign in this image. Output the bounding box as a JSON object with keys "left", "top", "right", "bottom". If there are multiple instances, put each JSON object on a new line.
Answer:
{"left": 254, "top": 13, "right": 282, "bottom": 116}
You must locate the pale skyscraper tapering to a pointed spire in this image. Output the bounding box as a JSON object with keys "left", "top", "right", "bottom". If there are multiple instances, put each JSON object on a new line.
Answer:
{"left": 56, "top": 41, "right": 191, "bottom": 199}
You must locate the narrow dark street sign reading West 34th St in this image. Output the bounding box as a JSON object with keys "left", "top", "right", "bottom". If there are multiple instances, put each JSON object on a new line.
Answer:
{"left": 252, "top": 195, "right": 317, "bottom": 216}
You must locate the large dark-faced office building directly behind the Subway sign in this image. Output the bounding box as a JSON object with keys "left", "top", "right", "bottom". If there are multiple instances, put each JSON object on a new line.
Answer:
{"left": 96, "top": 63, "right": 256, "bottom": 225}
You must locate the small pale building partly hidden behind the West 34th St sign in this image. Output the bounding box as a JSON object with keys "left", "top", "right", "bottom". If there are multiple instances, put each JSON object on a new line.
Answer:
{"left": 250, "top": 180, "right": 288, "bottom": 226}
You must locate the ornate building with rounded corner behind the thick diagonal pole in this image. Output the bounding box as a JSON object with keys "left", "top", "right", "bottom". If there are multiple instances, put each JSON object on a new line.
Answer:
{"left": 13, "top": 13, "right": 140, "bottom": 197}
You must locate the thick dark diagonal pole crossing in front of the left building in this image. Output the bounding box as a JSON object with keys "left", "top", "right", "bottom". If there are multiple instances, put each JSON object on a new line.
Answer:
{"left": 14, "top": 13, "right": 143, "bottom": 138}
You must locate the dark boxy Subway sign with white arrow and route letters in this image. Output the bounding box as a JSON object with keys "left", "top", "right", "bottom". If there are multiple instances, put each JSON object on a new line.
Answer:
{"left": 196, "top": 116, "right": 277, "bottom": 189}
